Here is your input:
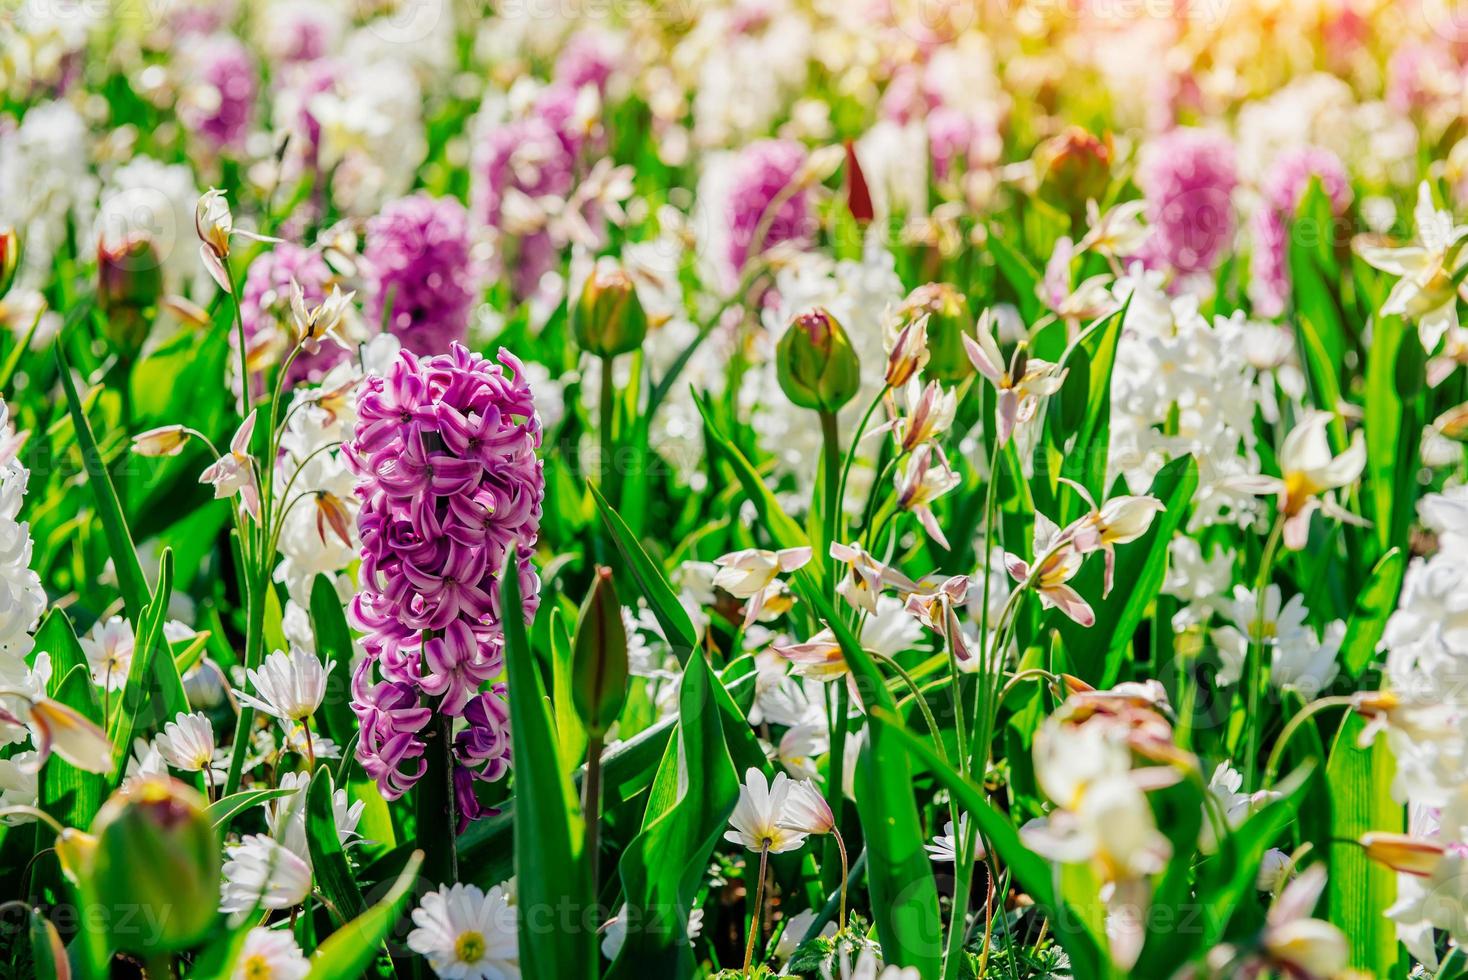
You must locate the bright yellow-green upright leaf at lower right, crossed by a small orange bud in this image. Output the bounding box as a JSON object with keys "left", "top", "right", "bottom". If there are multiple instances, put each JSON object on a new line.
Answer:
{"left": 1326, "top": 712, "right": 1406, "bottom": 977}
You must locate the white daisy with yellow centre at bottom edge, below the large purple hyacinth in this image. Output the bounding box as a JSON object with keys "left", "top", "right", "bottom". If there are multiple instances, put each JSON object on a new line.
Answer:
{"left": 408, "top": 883, "right": 520, "bottom": 980}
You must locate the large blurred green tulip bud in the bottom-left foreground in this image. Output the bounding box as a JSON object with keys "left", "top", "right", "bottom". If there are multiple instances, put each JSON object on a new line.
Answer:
{"left": 88, "top": 776, "right": 220, "bottom": 954}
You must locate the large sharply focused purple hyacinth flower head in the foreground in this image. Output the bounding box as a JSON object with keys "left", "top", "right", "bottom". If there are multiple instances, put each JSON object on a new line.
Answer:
{"left": 346, "top": 343, "right": 545, "bottom": 820}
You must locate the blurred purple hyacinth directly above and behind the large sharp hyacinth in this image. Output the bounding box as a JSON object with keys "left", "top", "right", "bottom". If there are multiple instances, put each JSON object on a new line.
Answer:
{"left": 363, "top": 194, "right": 483, "bottom": 355}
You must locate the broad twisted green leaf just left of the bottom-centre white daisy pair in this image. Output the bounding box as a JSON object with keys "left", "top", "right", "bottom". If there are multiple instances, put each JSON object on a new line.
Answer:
{"left": 609, "top": 645, "right": 738, "bottom": 977}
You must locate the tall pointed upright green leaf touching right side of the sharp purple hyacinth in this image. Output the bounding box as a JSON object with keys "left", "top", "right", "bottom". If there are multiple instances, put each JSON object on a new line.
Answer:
{"left": 499, "top": 557, "right": 605, "bottom": 980}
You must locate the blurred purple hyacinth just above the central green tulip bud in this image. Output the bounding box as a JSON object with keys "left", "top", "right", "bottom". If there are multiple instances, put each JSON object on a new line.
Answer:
{"left": 724, "top": 139, "right": 810, "bottom": 274}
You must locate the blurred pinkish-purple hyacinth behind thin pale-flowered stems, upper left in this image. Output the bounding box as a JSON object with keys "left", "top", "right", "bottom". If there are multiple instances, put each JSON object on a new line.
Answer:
{"left": 245, "top": 242, "right": 349, "bottom": 384}
